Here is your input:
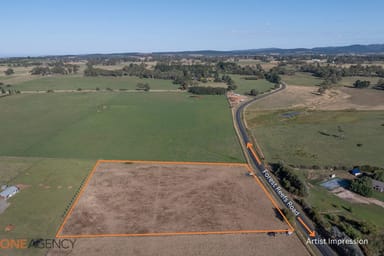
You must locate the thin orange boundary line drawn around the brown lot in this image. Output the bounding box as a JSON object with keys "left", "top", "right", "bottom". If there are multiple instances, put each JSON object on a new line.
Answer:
{"left": 56, "top": 160, "right": 294, "bottom": 238}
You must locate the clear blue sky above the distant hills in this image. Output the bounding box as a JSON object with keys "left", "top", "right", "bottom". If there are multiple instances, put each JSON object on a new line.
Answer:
{"left": 0, "top": 0, "right": 384, "bottom": 56}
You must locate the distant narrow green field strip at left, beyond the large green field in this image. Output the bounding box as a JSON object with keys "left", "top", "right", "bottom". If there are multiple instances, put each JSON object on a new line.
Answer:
{"left": 13, "top": 75, "right": 178, "bottom": 91}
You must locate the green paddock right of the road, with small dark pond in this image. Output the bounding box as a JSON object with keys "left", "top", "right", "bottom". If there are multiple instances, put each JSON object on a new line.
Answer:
{"left": 246, "top": 109, "right": 384, "bottom": 166}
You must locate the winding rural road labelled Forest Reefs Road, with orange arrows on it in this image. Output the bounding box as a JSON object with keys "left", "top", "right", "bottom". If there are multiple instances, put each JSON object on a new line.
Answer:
{"left": 231, "top": 83, "right": 336, "bottom": 256}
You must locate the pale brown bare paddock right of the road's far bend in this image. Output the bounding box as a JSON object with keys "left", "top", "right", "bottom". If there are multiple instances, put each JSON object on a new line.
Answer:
{"left": 249, "top": 85, "right": 384, "bottom": 110}
